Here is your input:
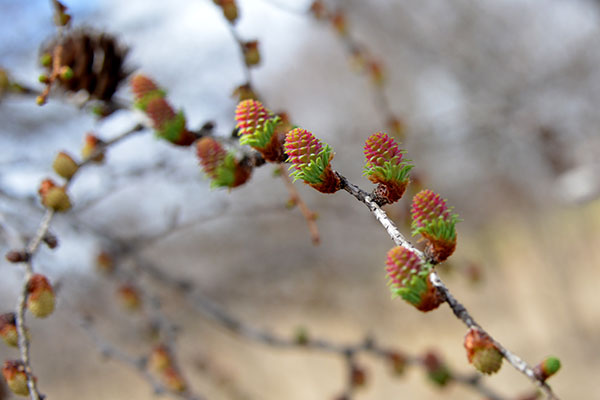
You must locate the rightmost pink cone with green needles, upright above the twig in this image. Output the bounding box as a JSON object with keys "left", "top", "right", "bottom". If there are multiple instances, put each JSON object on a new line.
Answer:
{"left": 411, "top": 189, "right": 459, "bottom": 262}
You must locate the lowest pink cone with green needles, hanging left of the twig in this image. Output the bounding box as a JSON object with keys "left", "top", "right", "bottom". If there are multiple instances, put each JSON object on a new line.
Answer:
{"left": 386, "top": 246, "right": 443, "bottom": 312}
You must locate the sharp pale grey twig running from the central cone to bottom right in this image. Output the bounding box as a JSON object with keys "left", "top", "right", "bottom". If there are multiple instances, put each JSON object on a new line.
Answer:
{"left": 338, "top": 173, "right": 558, "bottom": 400}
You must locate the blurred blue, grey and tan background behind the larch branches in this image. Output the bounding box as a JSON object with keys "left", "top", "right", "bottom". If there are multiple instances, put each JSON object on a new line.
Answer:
{"left": 0, "top": 0, "right": 600, "bottom": 400}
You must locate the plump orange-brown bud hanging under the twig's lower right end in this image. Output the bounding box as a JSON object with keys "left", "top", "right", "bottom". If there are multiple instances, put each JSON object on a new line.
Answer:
{"left": 465, "top": 328, "right": 502, "bottom": 375}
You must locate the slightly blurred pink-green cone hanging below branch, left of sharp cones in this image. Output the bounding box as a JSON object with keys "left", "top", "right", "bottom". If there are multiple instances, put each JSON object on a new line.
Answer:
{"left": 196, "top": 136, "right": 252, "bottom": 189}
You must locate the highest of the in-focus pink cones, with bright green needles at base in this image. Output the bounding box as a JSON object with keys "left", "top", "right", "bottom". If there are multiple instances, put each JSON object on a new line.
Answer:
{"left": 235, "top": 100, "right": 286, "bottom": 163}
